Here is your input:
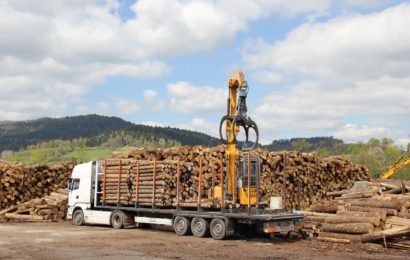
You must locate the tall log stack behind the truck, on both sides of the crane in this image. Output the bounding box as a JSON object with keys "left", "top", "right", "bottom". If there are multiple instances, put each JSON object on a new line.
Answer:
{"left": 112, "top": 146, "right": 369, "bottom": 209}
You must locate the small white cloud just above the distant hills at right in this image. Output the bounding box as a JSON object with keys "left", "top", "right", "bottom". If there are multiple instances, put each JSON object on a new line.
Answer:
{"left": 334, "top": 124, "right": 391, "bottom": 142}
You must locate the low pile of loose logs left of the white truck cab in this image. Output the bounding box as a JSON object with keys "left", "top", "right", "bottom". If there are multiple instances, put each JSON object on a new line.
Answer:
{"left": 0, "top": 189, "right": 68, "bottom": 221}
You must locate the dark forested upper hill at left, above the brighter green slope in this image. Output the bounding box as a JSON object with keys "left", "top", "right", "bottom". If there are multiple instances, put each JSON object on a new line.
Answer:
{"left": 0, "top": 115, "right": 219, "bottom": 152}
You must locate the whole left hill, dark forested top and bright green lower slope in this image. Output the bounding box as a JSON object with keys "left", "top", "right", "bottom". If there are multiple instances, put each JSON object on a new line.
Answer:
{"left": 0, "top": 115, "right": 220, "bottom": 164}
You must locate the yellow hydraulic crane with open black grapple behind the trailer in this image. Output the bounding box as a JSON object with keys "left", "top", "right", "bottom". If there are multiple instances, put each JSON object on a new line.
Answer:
{"left": 219, "top": 71, "right": 259, "bottom": 205}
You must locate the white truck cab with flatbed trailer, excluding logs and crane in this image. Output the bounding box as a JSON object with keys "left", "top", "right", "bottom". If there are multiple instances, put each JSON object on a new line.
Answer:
{"left": 67, "top": 161, "right": 303, "bottom": 239}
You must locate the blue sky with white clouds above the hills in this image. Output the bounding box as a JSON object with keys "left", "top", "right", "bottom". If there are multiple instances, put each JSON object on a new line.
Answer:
{"left": 0, "top": 0, "right": 410, "bottom": 145}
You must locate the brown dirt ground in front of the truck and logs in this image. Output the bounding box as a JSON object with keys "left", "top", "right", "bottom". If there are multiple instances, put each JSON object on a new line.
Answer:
{"left": 0, "top": 222, "right": 410, "bottom": 260}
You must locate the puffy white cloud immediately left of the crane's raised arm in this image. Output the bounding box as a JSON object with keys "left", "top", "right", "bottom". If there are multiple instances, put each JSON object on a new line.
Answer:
{"left": 167, "top": 81, "right": 227, "bottom": 114}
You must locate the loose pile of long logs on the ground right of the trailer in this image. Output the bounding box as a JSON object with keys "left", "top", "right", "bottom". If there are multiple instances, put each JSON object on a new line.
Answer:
{"left": 303, "top": 182, "right": 410, "bottom": 248}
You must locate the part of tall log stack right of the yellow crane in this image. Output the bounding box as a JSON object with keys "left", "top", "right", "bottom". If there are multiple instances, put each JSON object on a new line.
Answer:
{"left": 259, "top": 151, "right": 369, "bottom": 209}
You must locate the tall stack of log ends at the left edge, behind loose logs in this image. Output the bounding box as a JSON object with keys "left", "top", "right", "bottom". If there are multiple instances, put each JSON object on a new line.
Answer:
{"left": 0, "top": 161, "right": 74, "bottom": 210}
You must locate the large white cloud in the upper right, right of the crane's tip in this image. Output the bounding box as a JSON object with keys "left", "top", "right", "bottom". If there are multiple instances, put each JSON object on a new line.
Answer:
{"left": 244, "top": 4, "right": 410, "bottom": 83}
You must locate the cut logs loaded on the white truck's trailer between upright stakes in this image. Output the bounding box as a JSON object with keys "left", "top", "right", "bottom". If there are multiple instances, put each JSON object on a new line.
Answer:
{"left": 99, "top": 159, "right": 220, "bottom": 207}
